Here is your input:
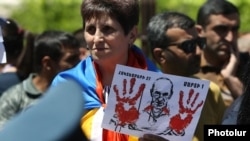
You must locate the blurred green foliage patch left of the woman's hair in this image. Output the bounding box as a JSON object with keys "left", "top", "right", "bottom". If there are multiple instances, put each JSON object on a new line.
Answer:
{"left": 11, "top": 0, "right": 82, "bottom": 33}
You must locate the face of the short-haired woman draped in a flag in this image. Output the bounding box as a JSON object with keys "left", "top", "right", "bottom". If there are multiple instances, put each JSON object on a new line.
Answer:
{"left": 84, "top": 15, "right": 132, "bottom": 64}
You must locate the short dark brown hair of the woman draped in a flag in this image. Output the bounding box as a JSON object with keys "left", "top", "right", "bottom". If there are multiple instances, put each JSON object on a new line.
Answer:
{"left": 81, "top": 0, "right": 139, "bottom": 35}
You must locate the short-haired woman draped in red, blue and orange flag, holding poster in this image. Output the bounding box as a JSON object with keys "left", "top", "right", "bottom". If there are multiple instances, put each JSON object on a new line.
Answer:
{"left": 52, "top": 0, "right": 166, "bottom": 141}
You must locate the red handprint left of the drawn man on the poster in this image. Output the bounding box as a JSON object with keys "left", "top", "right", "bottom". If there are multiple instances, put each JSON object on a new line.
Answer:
{"left": 113, "top": 78, "right": 145, "bottom": 127}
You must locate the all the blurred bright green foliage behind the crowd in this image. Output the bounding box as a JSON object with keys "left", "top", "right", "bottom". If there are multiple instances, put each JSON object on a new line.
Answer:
{"left": 11, "top": 0, "right": 250, "bottom": 32}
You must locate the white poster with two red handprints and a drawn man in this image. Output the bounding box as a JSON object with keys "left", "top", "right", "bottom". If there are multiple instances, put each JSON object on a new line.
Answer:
{"left": 102, "top": 65, "right": 209, "bottom": 141}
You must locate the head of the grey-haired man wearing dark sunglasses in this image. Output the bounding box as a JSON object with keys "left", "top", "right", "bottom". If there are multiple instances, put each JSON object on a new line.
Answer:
{"left": 147, "top": 12, "right": 206, "bottom": 76}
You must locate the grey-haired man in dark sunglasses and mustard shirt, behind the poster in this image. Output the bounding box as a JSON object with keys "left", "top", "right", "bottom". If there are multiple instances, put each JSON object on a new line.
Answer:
{"left": 147, "top": 12, "right": 226, "bottom": 141}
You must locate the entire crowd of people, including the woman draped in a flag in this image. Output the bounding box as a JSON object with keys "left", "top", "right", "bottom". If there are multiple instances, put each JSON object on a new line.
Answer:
{"left": 0, "top": 0, "right": 250, "bottom": 141}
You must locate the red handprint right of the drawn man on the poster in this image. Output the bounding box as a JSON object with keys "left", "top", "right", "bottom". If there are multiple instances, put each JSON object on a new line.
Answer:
{"left": 169, "top": 89, "right": 203, "bottom": 134}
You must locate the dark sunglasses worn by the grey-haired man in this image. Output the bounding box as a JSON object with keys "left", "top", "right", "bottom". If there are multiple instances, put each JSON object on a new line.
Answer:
{"left": 168, "top": 37, "right": 206, "bottom": 53}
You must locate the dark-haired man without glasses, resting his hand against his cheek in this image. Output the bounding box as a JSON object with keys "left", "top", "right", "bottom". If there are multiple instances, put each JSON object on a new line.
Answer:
{"left": 197, "top": 0, "right": 243, "bottom": 106}
